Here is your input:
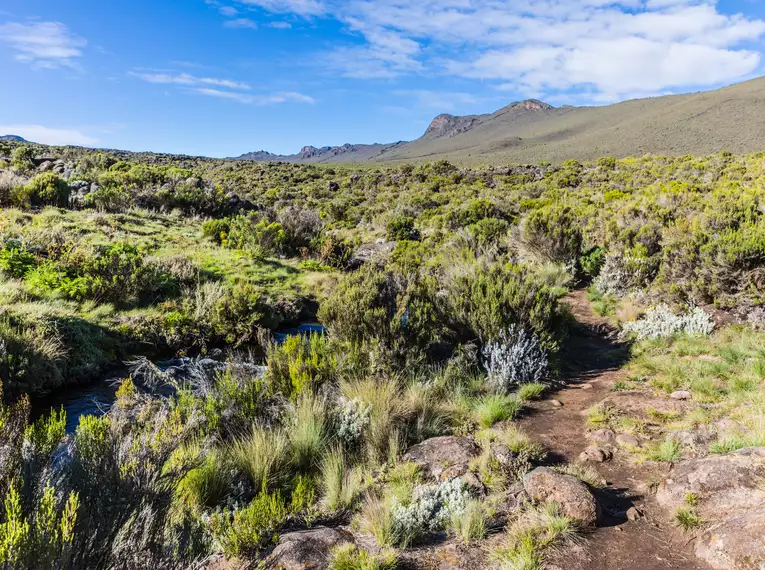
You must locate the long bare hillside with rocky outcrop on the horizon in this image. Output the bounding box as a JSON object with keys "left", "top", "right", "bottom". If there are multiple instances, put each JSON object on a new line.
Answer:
{"left": 241, "top": 78, "right": 765, "bottom": 163}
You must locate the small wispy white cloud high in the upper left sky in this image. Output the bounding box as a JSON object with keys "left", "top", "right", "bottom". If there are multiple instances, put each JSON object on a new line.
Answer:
{"left": 0, "top": 22, "right": 88, "bottom": 68}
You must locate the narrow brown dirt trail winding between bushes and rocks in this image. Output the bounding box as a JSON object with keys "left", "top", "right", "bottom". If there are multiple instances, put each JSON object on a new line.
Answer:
{"left": 521, "top": 291, "right": 708, "bottom": 570}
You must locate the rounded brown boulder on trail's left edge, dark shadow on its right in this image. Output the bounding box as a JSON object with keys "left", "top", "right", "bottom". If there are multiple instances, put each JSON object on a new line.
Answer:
{"left": 523, "top": 467, "right": 599, "bottom": 527}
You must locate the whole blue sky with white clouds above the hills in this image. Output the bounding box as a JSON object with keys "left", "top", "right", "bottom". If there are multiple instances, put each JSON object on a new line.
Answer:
{"left": 0, "top": 0, "right": 765, "bottom": 156}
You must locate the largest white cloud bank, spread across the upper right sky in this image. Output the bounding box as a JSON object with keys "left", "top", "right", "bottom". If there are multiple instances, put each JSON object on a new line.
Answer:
{"left": 245, "top": 0, "right": 765, "bottom": 101}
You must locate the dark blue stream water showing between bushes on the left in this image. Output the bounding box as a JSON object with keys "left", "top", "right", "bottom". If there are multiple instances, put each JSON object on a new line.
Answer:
{"left": 31, "top": 322, "right": 326, "bottom": 433}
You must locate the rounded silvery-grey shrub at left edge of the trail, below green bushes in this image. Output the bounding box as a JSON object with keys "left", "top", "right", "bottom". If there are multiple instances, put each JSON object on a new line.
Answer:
{"left": 483, "top": 325, "right": 550, "bottom": 393}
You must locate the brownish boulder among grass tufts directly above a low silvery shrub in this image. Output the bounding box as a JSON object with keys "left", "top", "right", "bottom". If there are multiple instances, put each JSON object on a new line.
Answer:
{"left": 402, "top": 436, "right": 481, "bottom": 480}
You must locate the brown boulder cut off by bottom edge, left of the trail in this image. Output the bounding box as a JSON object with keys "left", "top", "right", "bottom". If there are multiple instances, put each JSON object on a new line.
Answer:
{"left": 267, "top": 527, "right": 353, "bottom": 570}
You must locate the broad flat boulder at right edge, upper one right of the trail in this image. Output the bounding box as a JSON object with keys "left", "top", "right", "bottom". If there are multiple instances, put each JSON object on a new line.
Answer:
{"left": 656, "top": 447, "right": 765, "bottom": 520}
